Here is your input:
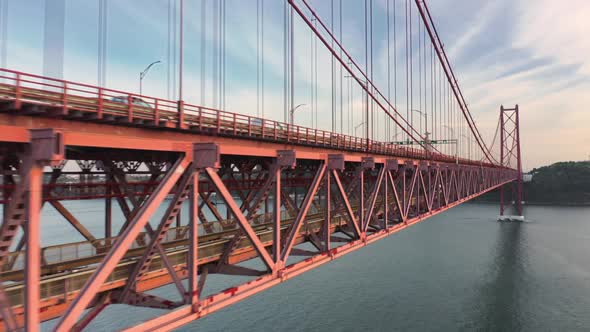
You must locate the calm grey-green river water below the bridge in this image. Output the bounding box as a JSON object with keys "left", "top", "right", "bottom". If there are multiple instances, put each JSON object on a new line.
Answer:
{"left": 35, "top": 203, "right": 590, "bottom": 332}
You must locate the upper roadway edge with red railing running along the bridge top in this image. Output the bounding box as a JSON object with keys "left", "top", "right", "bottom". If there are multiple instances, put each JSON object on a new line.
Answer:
{"left": 0, "top": 69, "right": 494, "bottom": 166}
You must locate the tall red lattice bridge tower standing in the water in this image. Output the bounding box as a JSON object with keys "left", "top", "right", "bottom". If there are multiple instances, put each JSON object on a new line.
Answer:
{"left": 500, "top": 105, "right": 524, "bottom": 221}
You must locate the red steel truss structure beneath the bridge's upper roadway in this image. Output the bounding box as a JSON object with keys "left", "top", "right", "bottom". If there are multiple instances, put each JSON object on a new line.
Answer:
{"left": 0, "top": 122, "right": 518, "bottom": 331}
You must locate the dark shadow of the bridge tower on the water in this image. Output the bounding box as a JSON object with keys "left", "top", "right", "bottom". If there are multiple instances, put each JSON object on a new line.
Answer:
{"left": 471, "top": 222, "right": 527, "bottom": 331}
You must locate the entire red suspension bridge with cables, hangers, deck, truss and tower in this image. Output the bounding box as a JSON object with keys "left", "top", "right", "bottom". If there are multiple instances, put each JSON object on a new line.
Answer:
{"left": 0, "top": 0, "right": 522, "bottom": 331}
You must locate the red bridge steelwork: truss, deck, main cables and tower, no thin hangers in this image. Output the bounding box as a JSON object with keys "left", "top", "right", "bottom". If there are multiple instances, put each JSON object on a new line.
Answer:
{"left": 0, "top": 0, "right": 522, "bottom": 331}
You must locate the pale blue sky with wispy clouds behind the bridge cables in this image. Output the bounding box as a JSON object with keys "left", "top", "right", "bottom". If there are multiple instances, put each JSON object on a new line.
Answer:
{"left": 0, "top": 0, "right": 590, "bottom": 170}
